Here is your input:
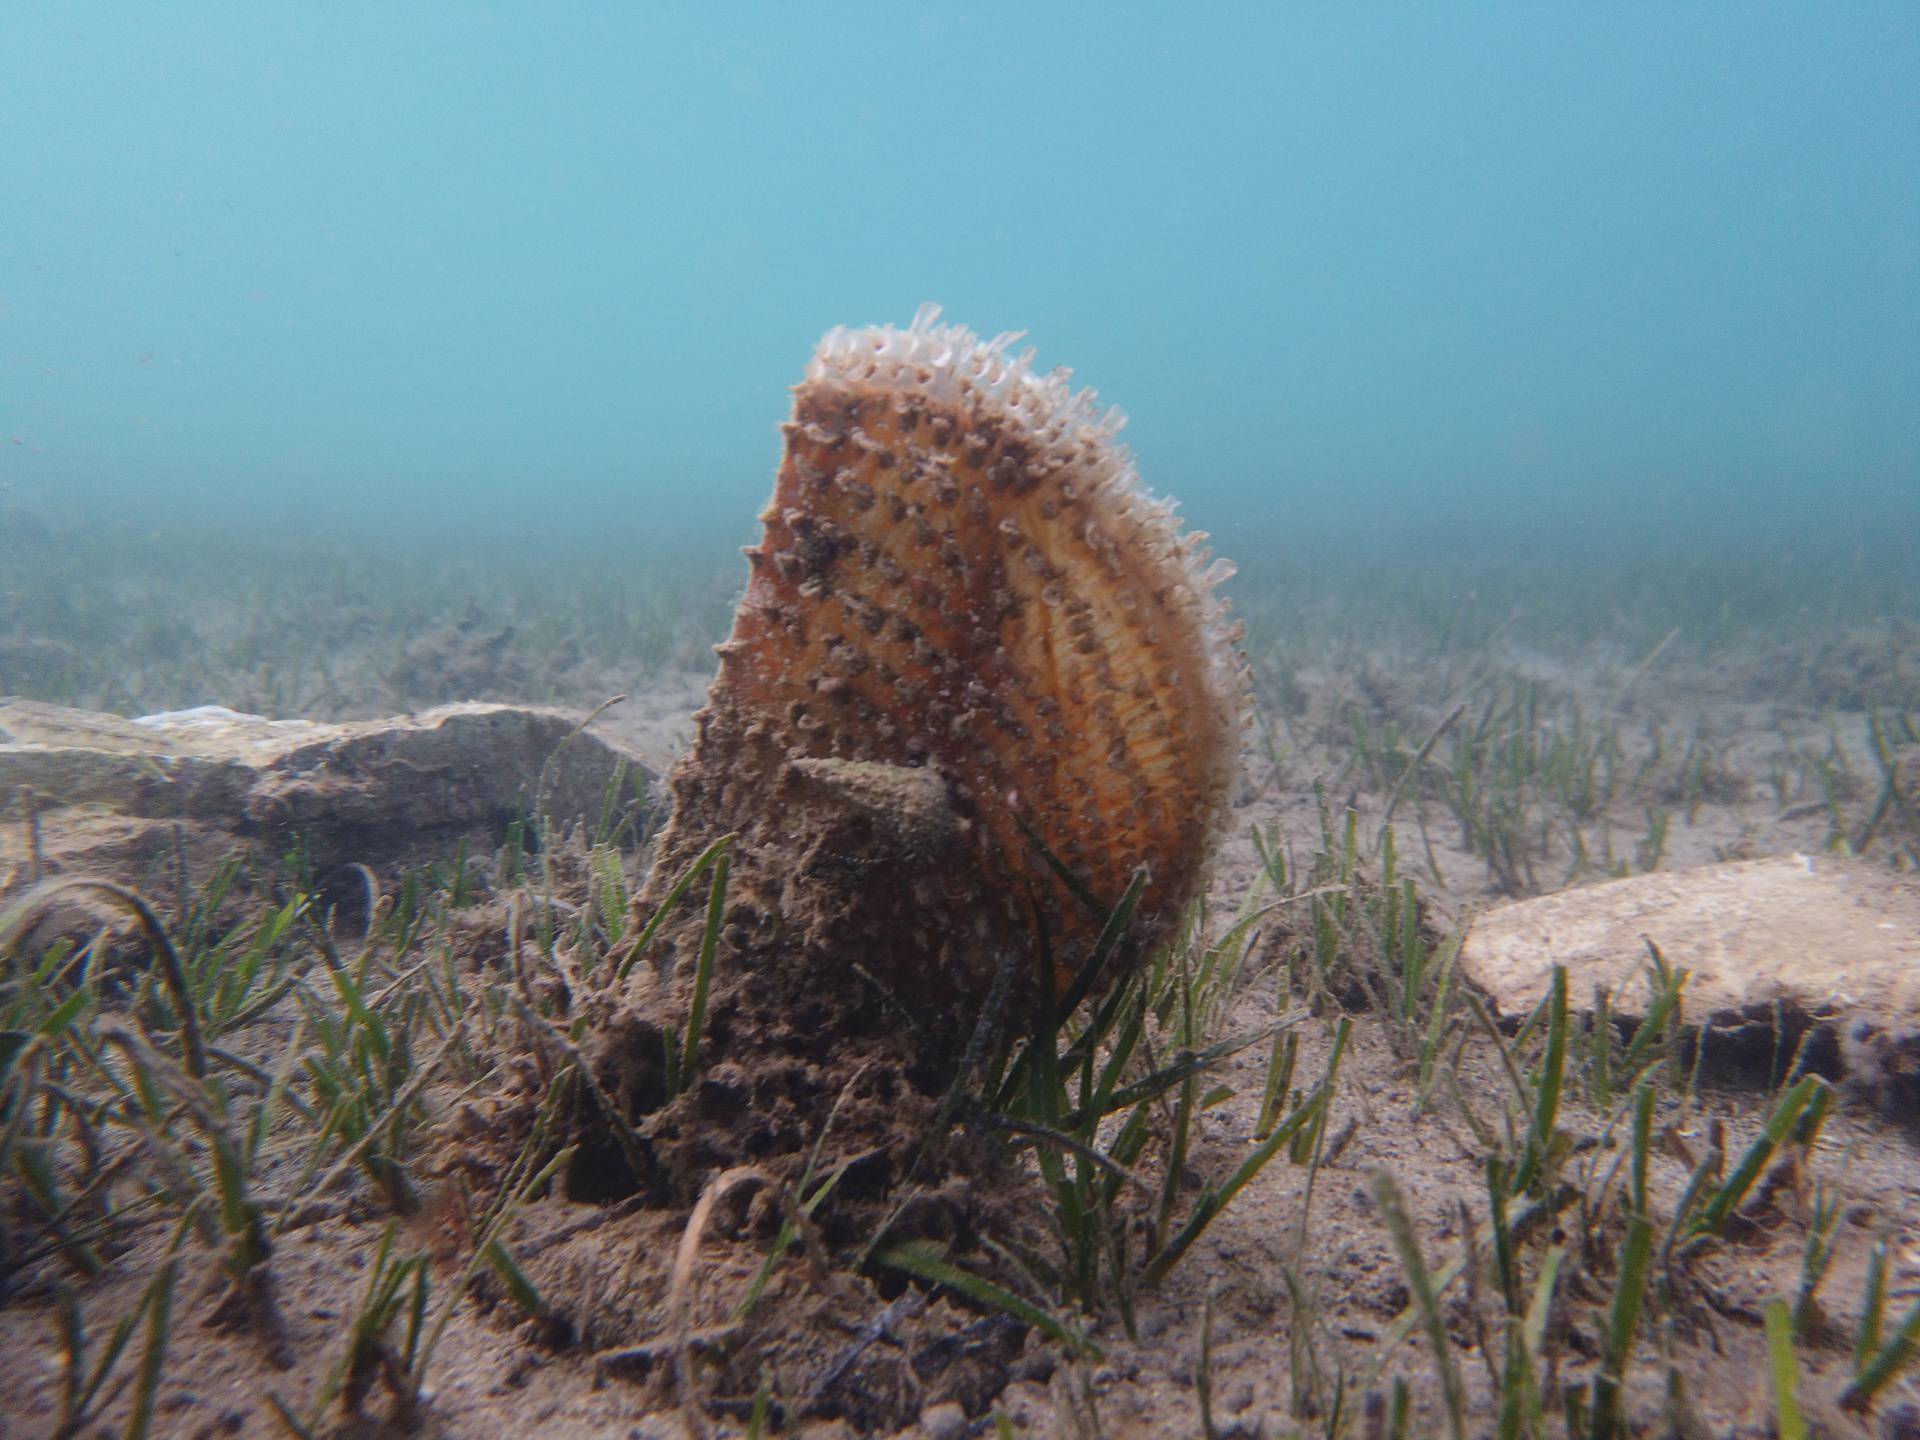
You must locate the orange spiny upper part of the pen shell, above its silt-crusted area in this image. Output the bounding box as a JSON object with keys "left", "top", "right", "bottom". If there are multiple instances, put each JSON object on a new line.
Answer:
{"left": 645, "top": 305, "right": 1246, "bottom": 1006}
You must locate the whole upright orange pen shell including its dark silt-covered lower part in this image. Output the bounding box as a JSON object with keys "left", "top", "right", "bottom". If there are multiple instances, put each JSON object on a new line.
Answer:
{"left": 641, "top": 305, "right": 1248, "bottom": 1039}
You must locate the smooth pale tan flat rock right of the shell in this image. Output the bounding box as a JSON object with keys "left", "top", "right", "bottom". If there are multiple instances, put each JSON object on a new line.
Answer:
{"left": 1459, "top": 854, "right": 1920, "bottom": 1085}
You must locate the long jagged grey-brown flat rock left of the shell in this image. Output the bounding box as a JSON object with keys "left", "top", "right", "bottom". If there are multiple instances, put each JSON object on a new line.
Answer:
{"left": 0, "top": 699, "right": 655, "bottom": 895}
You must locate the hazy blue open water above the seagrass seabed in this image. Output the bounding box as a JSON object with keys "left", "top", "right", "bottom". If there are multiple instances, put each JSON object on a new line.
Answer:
{"left": 0, "top": 0, "right": 1920, "bottom": 564}
